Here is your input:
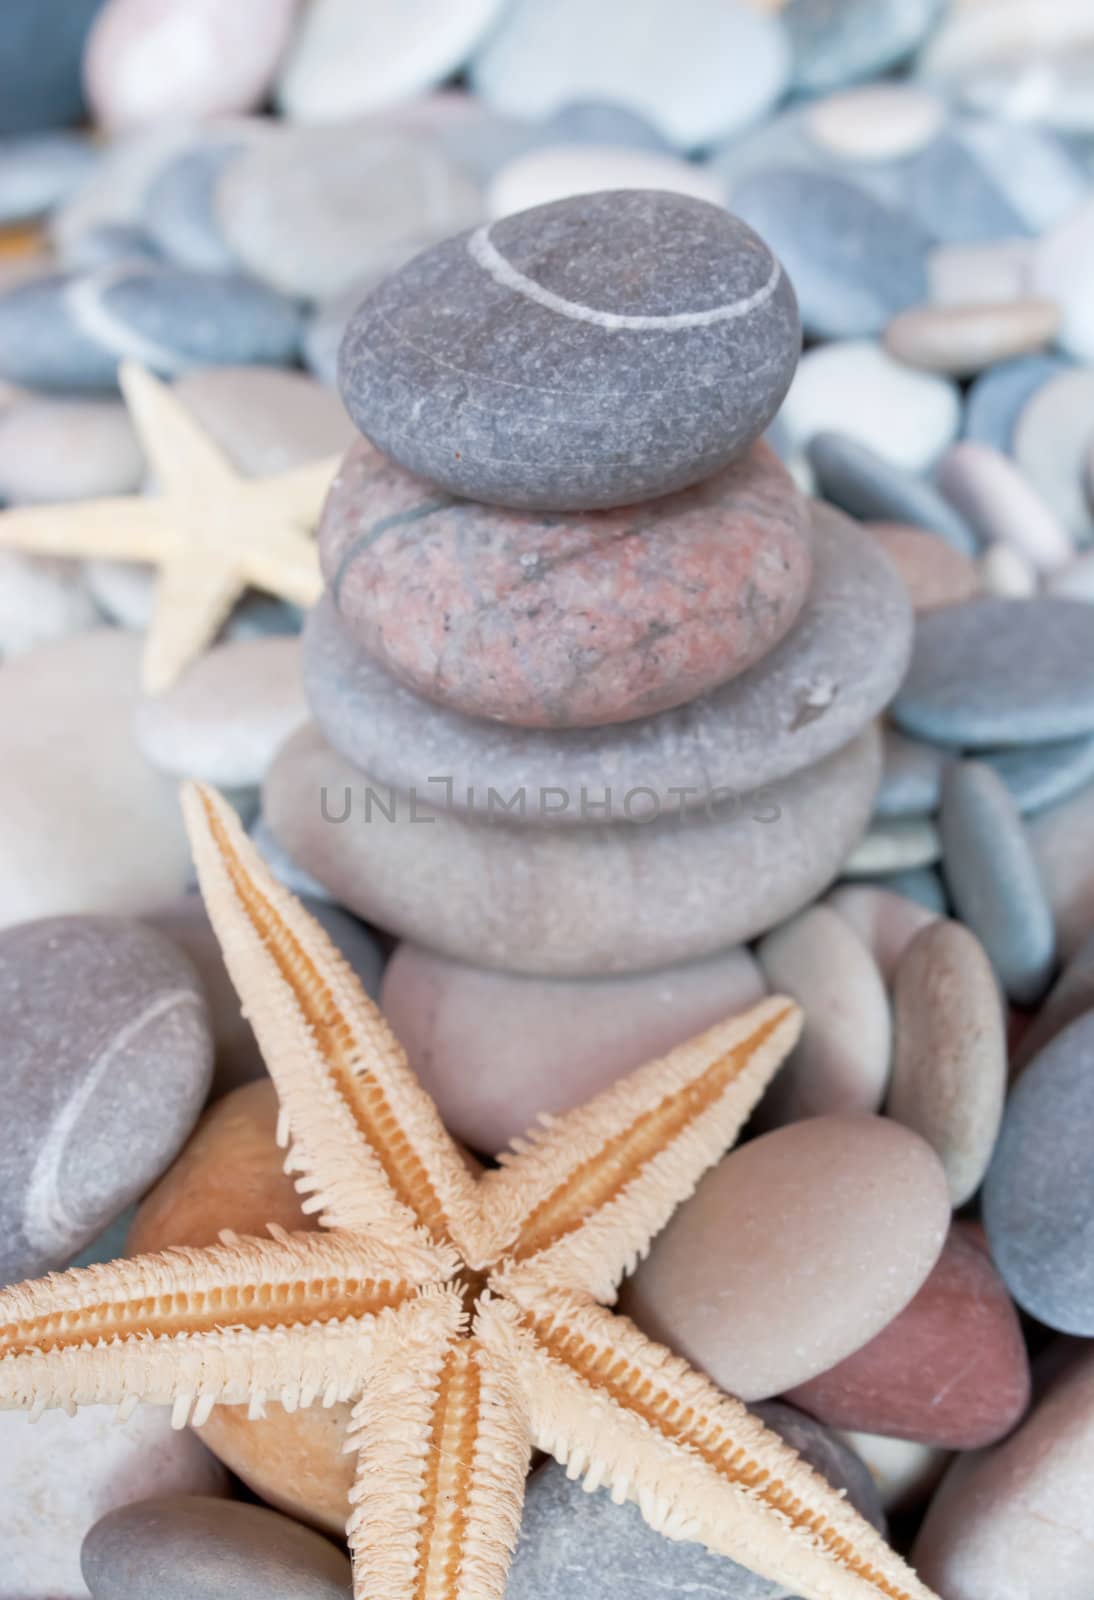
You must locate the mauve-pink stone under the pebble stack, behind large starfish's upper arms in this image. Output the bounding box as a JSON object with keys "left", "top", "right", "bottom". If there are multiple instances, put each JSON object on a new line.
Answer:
{"left": 381, "top": 944, "right": 766, "bottom": 1152}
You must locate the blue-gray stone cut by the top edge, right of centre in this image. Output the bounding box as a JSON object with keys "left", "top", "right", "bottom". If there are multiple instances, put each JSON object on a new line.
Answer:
{"left": 782, "top": 0, "right": 942, "bottom": 94}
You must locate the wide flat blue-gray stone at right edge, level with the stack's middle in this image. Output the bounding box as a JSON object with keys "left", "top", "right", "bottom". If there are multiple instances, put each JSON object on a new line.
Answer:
{"left": 891, "top": 595, "right": 1094, "bottom": 750}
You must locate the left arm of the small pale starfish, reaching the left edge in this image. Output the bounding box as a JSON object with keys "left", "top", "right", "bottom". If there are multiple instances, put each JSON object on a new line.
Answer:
{"left": 0, "top": 494, "right": 174, "bottom": 562}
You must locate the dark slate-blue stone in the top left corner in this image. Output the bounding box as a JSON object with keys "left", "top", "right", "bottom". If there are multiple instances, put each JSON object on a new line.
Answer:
{"left": 0, "top": 0, "right": 104, "bottom": 134}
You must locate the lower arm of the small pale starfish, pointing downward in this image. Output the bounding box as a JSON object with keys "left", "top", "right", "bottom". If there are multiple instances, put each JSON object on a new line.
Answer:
{"left": 141, "top": 549, "right": 246, "bottom": 694}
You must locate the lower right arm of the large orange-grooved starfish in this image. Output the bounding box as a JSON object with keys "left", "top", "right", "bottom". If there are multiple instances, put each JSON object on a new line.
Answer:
{"left": 480, "top": 1290, "right": 934, "bottom": 1600}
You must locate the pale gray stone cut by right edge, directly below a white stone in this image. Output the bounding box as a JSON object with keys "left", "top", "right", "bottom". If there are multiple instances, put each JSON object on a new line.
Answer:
{"left": 1012, "top": 366, "right": 1094, "bottom": 544}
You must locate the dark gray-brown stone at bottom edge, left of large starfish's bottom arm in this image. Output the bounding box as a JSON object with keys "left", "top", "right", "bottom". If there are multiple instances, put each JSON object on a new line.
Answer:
{"left": 80, "top": 1494, "right": 352, "bottom": 1600}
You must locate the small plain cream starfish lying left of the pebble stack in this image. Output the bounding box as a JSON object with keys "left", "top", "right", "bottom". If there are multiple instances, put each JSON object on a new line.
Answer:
{"left": 0, "top": 362, "right": 339, "bottom": 694}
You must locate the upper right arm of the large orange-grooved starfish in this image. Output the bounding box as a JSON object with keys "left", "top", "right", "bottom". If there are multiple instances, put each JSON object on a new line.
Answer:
{"left": 481, "top": 998, "right": 801, "bottom": 1301}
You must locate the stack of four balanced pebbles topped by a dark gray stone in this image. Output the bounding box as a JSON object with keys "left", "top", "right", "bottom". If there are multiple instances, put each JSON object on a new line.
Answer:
{"left": 264, "top": 190, "right": 912, "bottom": 976}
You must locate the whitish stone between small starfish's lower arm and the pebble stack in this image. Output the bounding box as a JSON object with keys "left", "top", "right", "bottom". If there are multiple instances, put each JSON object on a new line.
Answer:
{"left": 134, "top": 635, "right": 307, "bottom": 789}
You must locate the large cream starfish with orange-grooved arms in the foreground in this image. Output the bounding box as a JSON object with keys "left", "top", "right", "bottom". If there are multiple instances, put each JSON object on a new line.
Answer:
{"left": 0, "top": 786, "right": 929, "bottom": 1600}
